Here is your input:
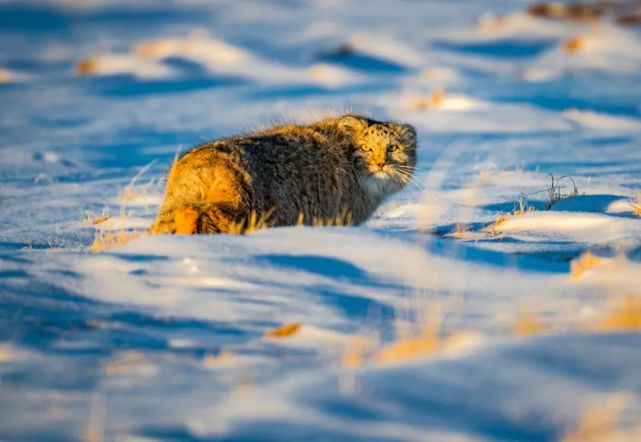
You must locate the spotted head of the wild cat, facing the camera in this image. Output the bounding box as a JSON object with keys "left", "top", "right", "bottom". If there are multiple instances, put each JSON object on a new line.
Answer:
{"left": 338, "top": 115, "right": 416, "bottom": 193}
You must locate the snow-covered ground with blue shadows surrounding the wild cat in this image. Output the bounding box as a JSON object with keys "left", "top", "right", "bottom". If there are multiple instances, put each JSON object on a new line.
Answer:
{"left": 0, "top": 0, "right": 641, "bottom": 441}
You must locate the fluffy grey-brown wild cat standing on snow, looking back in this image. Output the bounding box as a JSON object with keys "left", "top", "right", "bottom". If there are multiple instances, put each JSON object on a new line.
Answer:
{"left": 152, "top": 115, "right": 415, "bottom": 233}
